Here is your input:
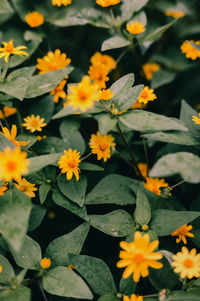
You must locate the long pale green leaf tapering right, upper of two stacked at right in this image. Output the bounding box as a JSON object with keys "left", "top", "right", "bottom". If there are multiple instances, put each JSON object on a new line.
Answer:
{"left": 119, "top": 110, "right": 187, "bottom": 132}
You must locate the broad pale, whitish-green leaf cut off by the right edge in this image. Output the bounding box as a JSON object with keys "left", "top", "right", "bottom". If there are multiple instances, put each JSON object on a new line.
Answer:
{"left": 150, "top": 152, "right": 200, "bottom": 183}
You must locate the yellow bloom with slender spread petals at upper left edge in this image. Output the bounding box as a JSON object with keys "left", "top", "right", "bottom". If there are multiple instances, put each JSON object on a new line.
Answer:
{"left": 0, "top": 40, "right": 28, "bottom": 63}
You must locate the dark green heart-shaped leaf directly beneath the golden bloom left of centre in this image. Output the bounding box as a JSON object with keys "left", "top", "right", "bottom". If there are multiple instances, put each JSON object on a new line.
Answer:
{"left": 57, "top": 174, "right": 87, "bottom": 207}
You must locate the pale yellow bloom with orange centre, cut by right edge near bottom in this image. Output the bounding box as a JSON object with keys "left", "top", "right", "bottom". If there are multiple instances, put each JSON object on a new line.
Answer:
{"left": 171, "top": 247, "right": 200, "bottom": 279}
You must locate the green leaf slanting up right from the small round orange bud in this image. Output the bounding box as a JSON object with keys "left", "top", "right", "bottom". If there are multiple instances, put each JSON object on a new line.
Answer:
{"left": 45, "top": 223, "right": 90, "bottom": 266}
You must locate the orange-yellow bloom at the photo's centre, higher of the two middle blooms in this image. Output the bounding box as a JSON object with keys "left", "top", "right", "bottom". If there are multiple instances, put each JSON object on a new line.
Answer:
{"left": 89, "top": 132, "right": 116, "bottom": 162}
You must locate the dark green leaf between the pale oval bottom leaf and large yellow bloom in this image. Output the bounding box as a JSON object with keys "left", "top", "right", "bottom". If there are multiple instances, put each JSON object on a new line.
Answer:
{"left": 69, "top": 255, "right": 116, "bottom": 296}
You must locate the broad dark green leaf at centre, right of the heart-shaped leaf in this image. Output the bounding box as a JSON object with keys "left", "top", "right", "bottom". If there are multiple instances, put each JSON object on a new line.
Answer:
{"left": 85, "top": 174, "right": 135, "bottom": 205}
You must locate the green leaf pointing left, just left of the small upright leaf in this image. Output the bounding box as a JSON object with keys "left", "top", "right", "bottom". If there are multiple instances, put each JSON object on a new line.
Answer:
{"left": 89, "top": 209, "right": 134, "bottom": 237}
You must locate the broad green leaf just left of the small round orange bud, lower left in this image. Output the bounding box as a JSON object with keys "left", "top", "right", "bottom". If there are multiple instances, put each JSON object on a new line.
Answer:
{"left": 10, "top": 236, "right": 42, "bottom": 270}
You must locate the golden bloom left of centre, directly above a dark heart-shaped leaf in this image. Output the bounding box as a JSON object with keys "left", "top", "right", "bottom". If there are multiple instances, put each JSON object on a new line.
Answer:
{"left": 58, "top": 148, "right": 81, "bottom": 181}
